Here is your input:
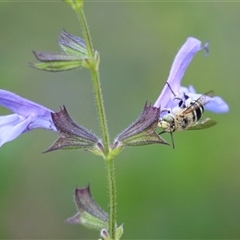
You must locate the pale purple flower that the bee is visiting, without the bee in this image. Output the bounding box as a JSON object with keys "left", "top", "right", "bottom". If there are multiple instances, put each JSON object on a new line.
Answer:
{"left": 154, "top": 37, "right": 229, "bottom": 116}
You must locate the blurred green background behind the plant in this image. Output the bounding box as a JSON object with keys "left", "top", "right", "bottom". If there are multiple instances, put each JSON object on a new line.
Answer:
{"left": 0, "top": 1, "right": 240, "bottom": 239}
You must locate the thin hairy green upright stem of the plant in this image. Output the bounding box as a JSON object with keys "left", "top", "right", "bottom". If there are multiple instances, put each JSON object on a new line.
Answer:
{"left": 77, "top": 6, "right": 116, "bottom": 240}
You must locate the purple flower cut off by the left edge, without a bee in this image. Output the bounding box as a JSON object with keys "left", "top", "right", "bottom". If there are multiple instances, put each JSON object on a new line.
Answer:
{"left": 0, "top": 89, "right": 57, "bottom": 147}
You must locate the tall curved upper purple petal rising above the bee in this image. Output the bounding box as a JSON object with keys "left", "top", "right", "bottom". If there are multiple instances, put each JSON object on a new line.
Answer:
{"left": 154, "top": 37, "right": 207, "bottom": 109}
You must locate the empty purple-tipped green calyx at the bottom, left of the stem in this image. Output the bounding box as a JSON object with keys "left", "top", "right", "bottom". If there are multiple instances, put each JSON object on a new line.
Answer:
{"left": 67, "top": 185, "right": 109, "bottom": 230}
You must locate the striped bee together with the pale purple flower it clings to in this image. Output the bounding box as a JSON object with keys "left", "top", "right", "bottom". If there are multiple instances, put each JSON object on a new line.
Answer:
{"left": 154, "top": 37, "right": 229, "bottom": 147}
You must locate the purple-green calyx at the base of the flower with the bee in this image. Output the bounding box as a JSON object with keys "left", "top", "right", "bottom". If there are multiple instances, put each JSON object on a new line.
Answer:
{"left": 112, "top": 102, "right": 168, "bottom": 152}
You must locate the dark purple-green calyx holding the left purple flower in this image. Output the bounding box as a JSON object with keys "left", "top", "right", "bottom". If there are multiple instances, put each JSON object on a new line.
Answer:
{"left": 45, "top": 106, "right": 103, "bottom": 155}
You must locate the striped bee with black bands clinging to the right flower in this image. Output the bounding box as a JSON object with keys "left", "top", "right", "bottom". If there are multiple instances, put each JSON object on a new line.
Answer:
{"left": 158, "top": 83, "right": 217, "bottom": 148}
